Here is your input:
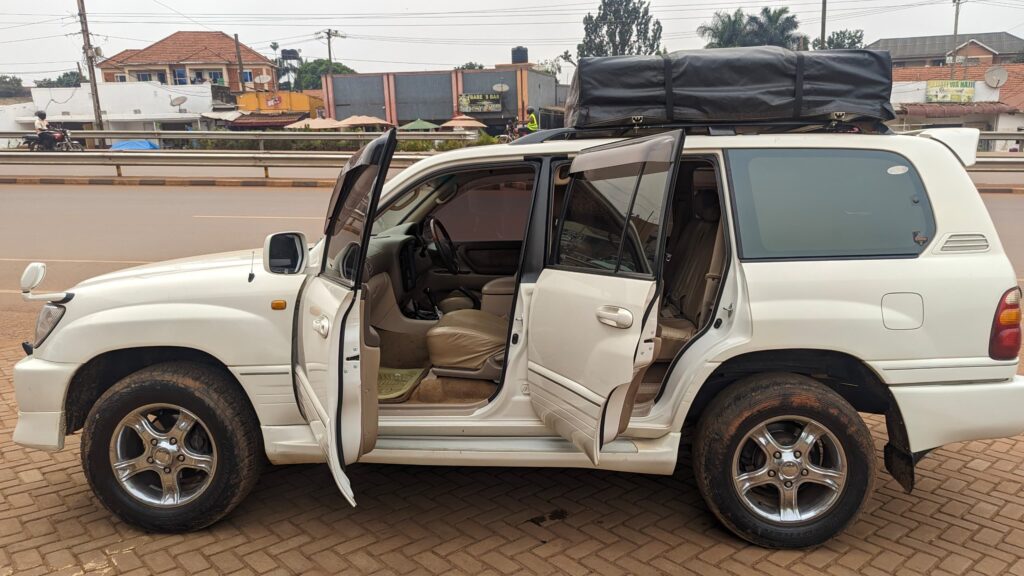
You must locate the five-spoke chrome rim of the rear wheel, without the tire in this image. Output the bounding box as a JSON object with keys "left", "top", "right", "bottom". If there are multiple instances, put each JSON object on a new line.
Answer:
{"left": 732, "top": 416, "right": 849, "bottom": 525}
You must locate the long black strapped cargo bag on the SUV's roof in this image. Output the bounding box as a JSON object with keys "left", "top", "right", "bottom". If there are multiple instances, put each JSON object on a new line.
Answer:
{"left": 565, "top": 46, "right": 895, "bottom": 128}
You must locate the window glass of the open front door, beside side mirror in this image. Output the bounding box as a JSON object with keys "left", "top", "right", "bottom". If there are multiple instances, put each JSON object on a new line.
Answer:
{"left": 323, "top": 164, "right": 380, "bottom": 284}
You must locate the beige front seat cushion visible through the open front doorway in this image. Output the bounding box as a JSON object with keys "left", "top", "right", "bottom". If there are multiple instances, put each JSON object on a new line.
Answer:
{"left": 427, "top": 310, "right": 508, "bottom": 380}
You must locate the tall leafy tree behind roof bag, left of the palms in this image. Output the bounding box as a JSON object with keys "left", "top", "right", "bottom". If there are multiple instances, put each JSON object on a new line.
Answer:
{"left": 563, "top": 0, "right": 663, "bottom": 58}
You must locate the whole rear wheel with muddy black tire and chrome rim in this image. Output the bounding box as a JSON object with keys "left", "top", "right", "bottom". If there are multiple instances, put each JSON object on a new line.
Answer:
{"left": 693, "top": 373, "right": 876, "bottom": 548}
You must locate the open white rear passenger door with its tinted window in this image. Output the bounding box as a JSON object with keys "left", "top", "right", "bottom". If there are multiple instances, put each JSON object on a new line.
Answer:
{"left": 526, "top": 130, "right": 683, "bottom": 464}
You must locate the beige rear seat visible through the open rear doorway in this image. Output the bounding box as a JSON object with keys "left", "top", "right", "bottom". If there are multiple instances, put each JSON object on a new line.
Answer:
{"left": 656, "top": 188, "right": 722, "bottom": 362}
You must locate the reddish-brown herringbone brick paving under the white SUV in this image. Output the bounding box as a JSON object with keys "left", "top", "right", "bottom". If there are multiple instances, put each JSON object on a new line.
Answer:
{"left": 0, "top": 314, "right": 1024, "bottom": 576}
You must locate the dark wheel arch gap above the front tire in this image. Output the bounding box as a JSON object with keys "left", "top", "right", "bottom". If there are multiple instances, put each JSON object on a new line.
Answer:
{"left": 63, "top": 346, "right": 255, "bottom": 435}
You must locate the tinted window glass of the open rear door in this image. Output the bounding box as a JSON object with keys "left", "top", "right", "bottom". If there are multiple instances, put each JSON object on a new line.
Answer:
{"left": 555, "top": 163, "right": 672, "bottom": 275}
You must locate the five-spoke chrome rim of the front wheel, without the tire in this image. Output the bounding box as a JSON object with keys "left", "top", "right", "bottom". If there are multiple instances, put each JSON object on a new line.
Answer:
{"left": 110, "top": 404, "right": 217, "bottom": 507}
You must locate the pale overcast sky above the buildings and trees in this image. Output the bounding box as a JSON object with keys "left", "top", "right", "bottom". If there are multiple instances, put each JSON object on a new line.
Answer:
{"left": 0, "top": 0, "right": 1024, "bottom": 84}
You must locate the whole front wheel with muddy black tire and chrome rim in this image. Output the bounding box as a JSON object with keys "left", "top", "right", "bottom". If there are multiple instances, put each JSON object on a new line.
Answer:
{"left": 82, "top": 362, "right": 262, "bottom": 532}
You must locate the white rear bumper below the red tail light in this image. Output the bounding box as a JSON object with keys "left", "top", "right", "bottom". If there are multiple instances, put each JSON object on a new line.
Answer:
{"left": 889, "top": 376, "right": 1024, "bottom": 452}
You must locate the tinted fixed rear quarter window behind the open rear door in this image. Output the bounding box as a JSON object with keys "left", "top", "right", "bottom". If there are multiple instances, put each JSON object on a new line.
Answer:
{"left": 728, "top": 149, "right": 935, "bottom": 259}
